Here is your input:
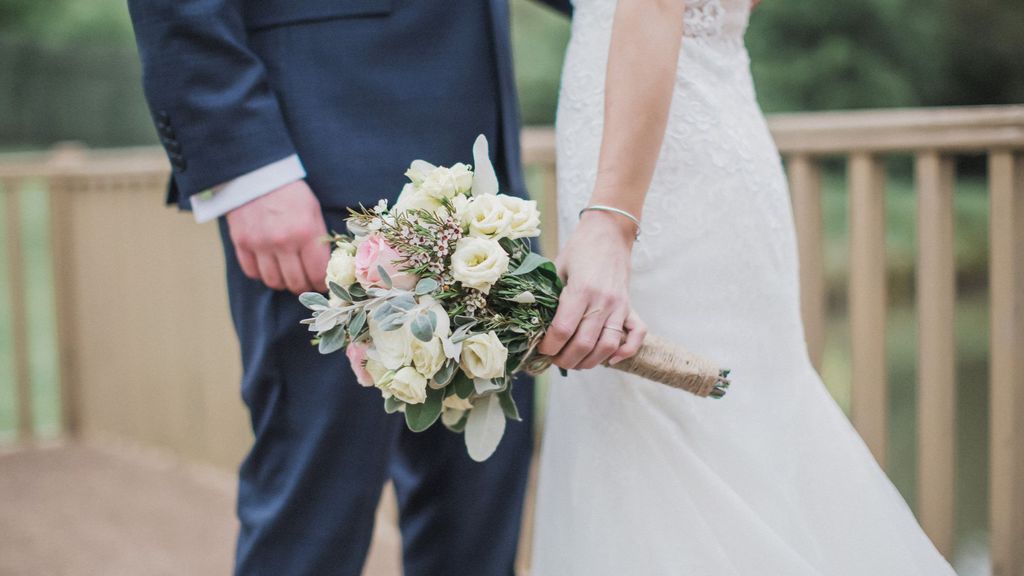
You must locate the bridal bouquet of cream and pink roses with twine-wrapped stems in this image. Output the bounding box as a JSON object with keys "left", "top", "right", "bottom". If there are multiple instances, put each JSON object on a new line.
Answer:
{"left": 300, "top": 136, "right": 728, "bottom": 461}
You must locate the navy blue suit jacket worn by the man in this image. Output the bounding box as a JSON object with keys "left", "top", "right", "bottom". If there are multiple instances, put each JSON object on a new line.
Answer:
{"left": 128, "top": 0, "right": 570, "bottom": 209}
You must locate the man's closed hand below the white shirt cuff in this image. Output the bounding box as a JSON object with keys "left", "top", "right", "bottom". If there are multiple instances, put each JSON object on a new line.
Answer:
{"left": 227, "top": 180, "right": 331, "bottom": 294}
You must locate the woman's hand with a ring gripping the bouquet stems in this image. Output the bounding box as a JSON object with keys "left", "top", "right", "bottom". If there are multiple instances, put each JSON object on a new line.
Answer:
{"left": 538, "top": 211, "right": 647, "bottom": 370}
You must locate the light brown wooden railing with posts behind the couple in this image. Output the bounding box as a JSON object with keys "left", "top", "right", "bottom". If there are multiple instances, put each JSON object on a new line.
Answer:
{"left": 0, "top": 107, "right": 1024, "bottom": 576}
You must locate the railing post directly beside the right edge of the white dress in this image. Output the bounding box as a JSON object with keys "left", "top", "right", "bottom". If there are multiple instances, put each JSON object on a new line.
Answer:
{"left": 786, "top": 154, "right": 826, "bottom": 372}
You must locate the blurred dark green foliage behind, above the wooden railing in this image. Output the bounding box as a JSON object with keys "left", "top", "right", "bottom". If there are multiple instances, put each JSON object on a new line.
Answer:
{"left": 0, "top": 0, "right": 1024, "bottom": 148}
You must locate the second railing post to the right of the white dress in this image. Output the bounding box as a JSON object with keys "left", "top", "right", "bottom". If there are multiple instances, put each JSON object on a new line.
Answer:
{"left": 849, "top": 153, "right": 889, "bottom": 468}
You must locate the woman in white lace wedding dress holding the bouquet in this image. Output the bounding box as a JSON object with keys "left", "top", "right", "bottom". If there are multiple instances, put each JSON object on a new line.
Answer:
{"left": 534, "top": 0, "right": 953, "bottom": 576}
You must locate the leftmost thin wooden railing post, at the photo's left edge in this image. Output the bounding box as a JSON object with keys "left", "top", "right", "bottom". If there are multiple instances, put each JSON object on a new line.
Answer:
{"left": 0, "top": 178, "right": 35, "bottom": 442}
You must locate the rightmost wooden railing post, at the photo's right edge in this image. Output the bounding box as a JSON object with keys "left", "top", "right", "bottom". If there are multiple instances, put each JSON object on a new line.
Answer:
{"left": 988, "top": 150, "right": 1024, "bottom": 576}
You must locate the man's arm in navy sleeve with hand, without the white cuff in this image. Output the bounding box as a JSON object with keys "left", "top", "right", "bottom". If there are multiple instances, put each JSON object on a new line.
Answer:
{"left": 128, "top": 0, "right": 330, "bottom": 292}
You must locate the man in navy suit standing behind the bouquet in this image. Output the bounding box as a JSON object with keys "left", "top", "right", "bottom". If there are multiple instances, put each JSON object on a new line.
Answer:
{"left": 128, "top": 0, "right": 568, "bottom": 576}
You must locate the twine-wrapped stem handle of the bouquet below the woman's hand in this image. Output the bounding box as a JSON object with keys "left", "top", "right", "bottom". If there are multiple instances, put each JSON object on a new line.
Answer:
{"left": 525, "top": 334, "right": 730, "bottom": 399}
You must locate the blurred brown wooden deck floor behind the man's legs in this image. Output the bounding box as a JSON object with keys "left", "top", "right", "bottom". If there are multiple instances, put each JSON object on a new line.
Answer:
{"left": 0, "top": 444, "right": 401, "bottom": 576}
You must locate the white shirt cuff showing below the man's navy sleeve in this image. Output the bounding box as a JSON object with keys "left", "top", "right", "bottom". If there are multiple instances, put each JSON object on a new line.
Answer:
{"left": 189, "top": 154, "right": 306, "bottom": 222}
